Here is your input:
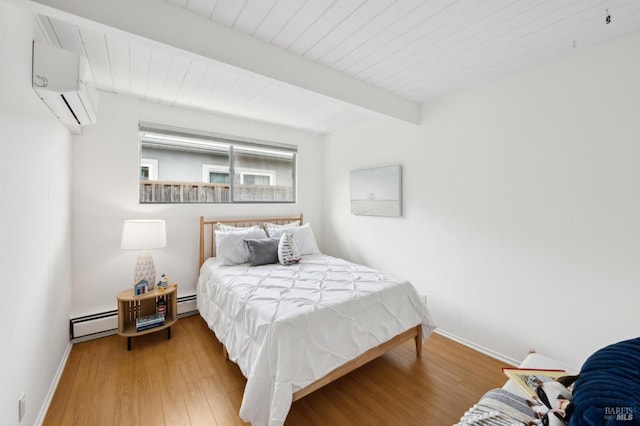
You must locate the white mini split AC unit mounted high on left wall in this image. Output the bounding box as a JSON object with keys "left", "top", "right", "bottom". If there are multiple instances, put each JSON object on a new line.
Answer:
{"left": 32, "top": 42, "right": 98, "bottom": 134}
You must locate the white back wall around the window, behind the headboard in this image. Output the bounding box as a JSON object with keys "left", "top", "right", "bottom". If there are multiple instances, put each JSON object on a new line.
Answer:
{"left": 71, "top": 92, "right": 323, "bottom": 318}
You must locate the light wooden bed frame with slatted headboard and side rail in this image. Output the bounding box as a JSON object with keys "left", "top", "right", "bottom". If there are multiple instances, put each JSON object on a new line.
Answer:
{"left": 199, "top": 213, "right": 422, "bottom": 401}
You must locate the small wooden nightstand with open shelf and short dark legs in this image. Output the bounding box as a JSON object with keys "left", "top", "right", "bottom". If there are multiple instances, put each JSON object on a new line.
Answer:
{"left": 118, "top": 284, "right": 178, "bottom": 351}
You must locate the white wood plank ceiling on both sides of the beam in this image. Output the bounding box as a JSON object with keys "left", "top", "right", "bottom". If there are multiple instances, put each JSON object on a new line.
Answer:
{"left": 32, "top": 0, "right": 640, "bottom": 133}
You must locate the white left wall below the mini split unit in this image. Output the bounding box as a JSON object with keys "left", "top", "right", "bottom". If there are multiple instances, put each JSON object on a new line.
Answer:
{"left": 0, "top": 2, "right": 71, "bottom": 425}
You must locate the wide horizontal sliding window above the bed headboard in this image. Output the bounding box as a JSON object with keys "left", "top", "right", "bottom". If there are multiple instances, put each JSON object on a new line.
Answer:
{"left": 138, "top": 123, "right": 297, "bottom": 203}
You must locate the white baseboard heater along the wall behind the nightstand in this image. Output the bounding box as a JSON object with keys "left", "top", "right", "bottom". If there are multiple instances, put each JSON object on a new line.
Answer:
{"left": 69, "top": 294, "right": 198, "bottom": 343}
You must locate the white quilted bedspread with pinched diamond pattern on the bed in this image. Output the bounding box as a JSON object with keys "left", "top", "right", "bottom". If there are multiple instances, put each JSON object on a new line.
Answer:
{"left": 197, "top": 255, "right": 435, "bottom": 426}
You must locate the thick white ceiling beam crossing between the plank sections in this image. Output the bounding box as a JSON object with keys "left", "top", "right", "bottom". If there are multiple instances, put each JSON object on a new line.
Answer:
{"left": 10, "top": 0, "right": 420, "bottom": 124}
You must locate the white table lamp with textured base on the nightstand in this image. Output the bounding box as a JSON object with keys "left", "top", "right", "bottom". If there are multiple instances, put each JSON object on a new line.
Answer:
{"left": 120, "top": 219, "right": 167, "bottom": 290}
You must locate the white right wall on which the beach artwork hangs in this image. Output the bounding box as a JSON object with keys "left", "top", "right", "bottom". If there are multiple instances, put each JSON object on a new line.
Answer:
{"left": 324, "top": 31, "right": 640, "bottom": 366}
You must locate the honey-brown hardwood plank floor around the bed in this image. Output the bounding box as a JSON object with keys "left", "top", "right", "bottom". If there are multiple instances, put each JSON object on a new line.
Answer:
{"left": 44, "top": 316, "right": 506, "bottom": 426}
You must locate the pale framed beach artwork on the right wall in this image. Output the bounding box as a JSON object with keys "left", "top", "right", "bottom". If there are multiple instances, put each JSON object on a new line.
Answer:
{"left": 351, "top": 166, "right": 402, "bottom": 217}
